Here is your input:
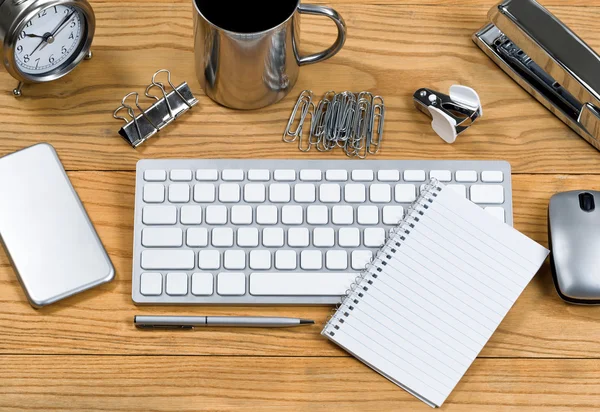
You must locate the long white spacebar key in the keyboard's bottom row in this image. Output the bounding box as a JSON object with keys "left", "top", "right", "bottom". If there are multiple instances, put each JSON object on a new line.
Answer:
{"left": 250, "top": 272, "right": 357, "bottom": 296}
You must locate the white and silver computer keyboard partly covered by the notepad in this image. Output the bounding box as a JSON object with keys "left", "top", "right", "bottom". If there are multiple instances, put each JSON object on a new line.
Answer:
{"left": 132, "top": 160, "right": 512, "bottom": 304}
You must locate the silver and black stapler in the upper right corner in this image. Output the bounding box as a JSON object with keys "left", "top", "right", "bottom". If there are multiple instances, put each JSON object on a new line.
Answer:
{"left": 473, "top": 0, "right": 600, "bottom": 150}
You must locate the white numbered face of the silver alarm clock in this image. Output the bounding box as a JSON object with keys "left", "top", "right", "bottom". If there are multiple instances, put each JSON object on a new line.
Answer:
{"left": 14, "top": 5, "right": 86, "bottom": 76}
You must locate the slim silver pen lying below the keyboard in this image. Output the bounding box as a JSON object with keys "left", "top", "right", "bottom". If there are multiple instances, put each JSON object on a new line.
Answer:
{"left": 133, "top": 316, "right": 315, "bottom": 329}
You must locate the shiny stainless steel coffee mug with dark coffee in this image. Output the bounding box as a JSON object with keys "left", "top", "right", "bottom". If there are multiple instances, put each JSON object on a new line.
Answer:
{"left": 194, "top": 0, "right": 346, "bottom": 109}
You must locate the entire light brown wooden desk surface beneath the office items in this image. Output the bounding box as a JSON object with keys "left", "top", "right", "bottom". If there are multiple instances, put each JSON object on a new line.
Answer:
{"left": 0, "top": 0, "right": 600, "bottom": 411}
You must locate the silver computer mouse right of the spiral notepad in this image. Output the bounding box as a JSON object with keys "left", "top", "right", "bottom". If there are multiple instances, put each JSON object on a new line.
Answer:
{"left": 548, "top": 190, "right": 600, "bottom": 305}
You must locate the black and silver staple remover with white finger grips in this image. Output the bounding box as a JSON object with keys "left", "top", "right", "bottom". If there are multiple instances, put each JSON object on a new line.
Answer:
{"left": 413, "top": 85, "right": 483, "bottom": 143}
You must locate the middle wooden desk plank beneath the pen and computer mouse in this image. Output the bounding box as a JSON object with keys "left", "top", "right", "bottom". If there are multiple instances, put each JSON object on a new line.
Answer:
{"left": 0, "top": 172, "right": 600, "bottom": 357}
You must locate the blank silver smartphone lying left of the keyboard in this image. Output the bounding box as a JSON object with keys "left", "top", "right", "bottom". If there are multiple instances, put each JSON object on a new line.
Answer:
{"left": 0, "top": 144, "right": 115, "bottom": 308}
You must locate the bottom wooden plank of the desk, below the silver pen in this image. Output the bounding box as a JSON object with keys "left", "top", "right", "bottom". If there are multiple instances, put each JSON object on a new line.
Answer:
{"left": 0, "top": 356, "right": 600, "bottom": 412}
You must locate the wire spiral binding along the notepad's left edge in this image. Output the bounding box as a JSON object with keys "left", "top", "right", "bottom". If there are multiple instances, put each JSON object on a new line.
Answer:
{"left": 325, "top": 179, "right": 442, "bottom": 336}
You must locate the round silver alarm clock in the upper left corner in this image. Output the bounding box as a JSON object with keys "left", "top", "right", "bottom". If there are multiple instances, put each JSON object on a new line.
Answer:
{"left": 0, "top": 0, "right": 96, "bottom": 96}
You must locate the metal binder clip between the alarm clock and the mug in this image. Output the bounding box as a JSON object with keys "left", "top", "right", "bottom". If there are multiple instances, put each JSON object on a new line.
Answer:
{"left": 113, "top": 69, "right": 198, "bottom": 148}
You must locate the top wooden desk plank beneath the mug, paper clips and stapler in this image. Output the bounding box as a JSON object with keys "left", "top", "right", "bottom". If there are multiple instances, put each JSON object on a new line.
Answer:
{"left": 0, "top": 1, "right": 600, "bottom": 174}
